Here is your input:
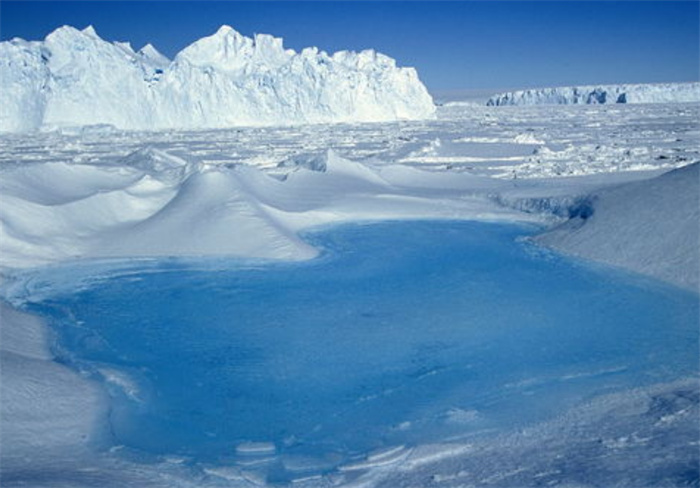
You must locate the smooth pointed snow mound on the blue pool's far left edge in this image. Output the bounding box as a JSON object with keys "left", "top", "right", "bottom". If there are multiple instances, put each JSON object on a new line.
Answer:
{"left": 94, "top": 168, "right": 316, "bottom": 259}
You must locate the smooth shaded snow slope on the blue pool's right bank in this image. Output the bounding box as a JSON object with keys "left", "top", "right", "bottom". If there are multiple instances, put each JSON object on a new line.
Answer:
{"left": 535, "top": 163, "right": 700, "bottom": 290}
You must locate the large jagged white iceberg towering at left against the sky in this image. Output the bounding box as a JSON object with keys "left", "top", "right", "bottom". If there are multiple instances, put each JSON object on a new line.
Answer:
{"left": 0, "top": 26, "right": 435, "bottom": 132}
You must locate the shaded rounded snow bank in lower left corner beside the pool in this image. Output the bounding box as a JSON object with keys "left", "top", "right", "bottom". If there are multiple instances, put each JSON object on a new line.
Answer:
{"left": 0, "top": 301, "right": 107, "bottom": 472}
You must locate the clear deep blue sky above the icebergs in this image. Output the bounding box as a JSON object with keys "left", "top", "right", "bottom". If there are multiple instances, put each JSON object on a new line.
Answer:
{"left": 0, "top": 0, "right": 700, "bottom": 92}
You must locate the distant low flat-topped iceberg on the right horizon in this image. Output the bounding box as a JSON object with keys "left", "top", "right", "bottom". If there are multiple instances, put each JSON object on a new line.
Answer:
{"left": 486, "top": 83, "right": 700, "bottom": 106}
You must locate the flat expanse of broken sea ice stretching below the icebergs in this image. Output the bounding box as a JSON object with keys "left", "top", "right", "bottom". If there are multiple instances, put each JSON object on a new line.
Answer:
{"left": 0, "top": 103, "right": 700, "bottom": 179}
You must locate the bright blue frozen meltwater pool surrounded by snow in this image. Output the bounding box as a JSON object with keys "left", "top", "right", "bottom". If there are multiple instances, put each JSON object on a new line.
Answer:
{"left": 19, "top": 221, "right": 698, "bottom": 482}
